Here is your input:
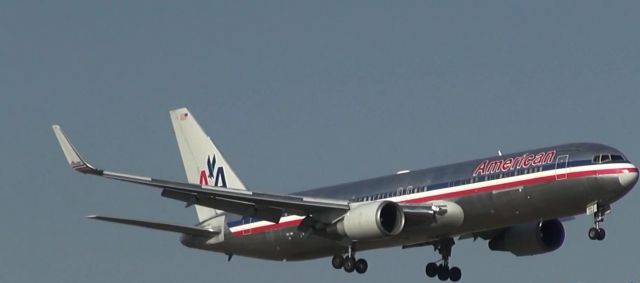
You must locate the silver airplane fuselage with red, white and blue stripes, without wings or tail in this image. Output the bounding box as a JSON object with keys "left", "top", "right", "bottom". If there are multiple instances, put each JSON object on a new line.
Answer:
{"left": 181, "top": 143, "right": 638, "bottom": 260}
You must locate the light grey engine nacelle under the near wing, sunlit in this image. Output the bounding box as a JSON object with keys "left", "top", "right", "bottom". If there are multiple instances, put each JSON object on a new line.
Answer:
{"left": 335, "top": 201, "right": 404, "bottom": 240}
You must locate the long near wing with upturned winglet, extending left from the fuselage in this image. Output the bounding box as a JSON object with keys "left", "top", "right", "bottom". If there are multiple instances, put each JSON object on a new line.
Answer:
{"left": 52, "top": 125, "right": 350, "bottom": 223}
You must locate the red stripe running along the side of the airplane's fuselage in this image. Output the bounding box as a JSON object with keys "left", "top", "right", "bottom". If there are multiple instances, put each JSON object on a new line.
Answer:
{"left": 232, "top": 168, "right": 638, "bottom": 236}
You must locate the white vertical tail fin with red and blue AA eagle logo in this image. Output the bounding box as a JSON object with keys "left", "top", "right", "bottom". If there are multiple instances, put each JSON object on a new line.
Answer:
{"left": 169, "top": 108, "right": 246, "bottom": 221}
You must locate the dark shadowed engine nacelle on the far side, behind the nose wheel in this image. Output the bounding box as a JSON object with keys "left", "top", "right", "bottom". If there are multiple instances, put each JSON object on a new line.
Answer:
{"left": 489, "top": 219, "right": 564, "bottom": 256}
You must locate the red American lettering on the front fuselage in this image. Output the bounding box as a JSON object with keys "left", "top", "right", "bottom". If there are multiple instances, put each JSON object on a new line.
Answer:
{"left": 473, "top": 150, "right": 556, "bottom": 176}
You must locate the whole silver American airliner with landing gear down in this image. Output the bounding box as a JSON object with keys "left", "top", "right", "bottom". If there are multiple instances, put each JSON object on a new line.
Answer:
{"left": 52, "top": 108, "right": 638, "bottom": 282}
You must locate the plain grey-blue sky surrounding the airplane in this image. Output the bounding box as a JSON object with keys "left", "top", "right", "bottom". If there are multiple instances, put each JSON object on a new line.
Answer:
{"left": 0, "top": 1, "right": 640, "bottom": 283}
